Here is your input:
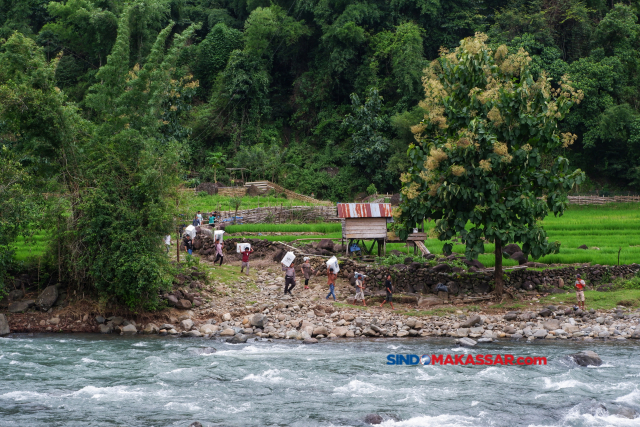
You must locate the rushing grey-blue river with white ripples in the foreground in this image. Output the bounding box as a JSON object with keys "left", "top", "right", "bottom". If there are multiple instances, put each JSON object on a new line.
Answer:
{"left": 0, "top": 334, "right": 640, "bottom": 427}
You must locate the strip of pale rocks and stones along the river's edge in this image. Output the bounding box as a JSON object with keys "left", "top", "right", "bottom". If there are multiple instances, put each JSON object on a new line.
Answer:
{"left": 0, "top": 267, "right": 640, "bottom": 343}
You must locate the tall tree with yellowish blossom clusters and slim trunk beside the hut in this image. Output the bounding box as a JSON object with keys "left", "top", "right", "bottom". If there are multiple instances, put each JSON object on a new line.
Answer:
{"left": 396, "top": 34, "right": 584, "bottom": 294}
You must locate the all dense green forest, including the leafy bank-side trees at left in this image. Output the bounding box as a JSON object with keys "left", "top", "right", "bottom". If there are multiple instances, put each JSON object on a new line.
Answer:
{"left": 0, "top": 0, "right": 640, "bottom": 305}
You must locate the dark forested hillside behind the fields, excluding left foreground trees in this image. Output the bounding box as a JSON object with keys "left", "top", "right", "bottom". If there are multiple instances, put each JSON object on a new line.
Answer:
{"left": 5, "top": 0, "right": 640, "bottom": 200}
